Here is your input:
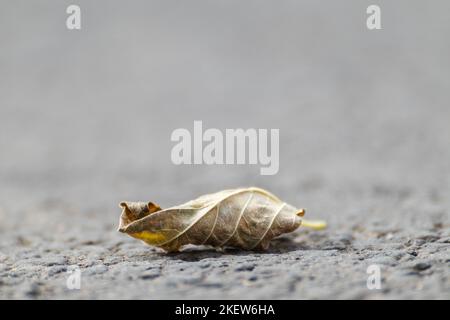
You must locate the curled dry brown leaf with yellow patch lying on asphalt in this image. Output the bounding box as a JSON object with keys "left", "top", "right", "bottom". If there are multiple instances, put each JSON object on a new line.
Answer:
{"left": 119, "top": 188, "right": 325, "bottom": 252}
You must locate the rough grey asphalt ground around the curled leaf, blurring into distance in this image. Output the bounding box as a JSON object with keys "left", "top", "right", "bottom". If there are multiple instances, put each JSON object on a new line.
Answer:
{"left": 0, "top": 0, "right": 450, "bottom": 299}
